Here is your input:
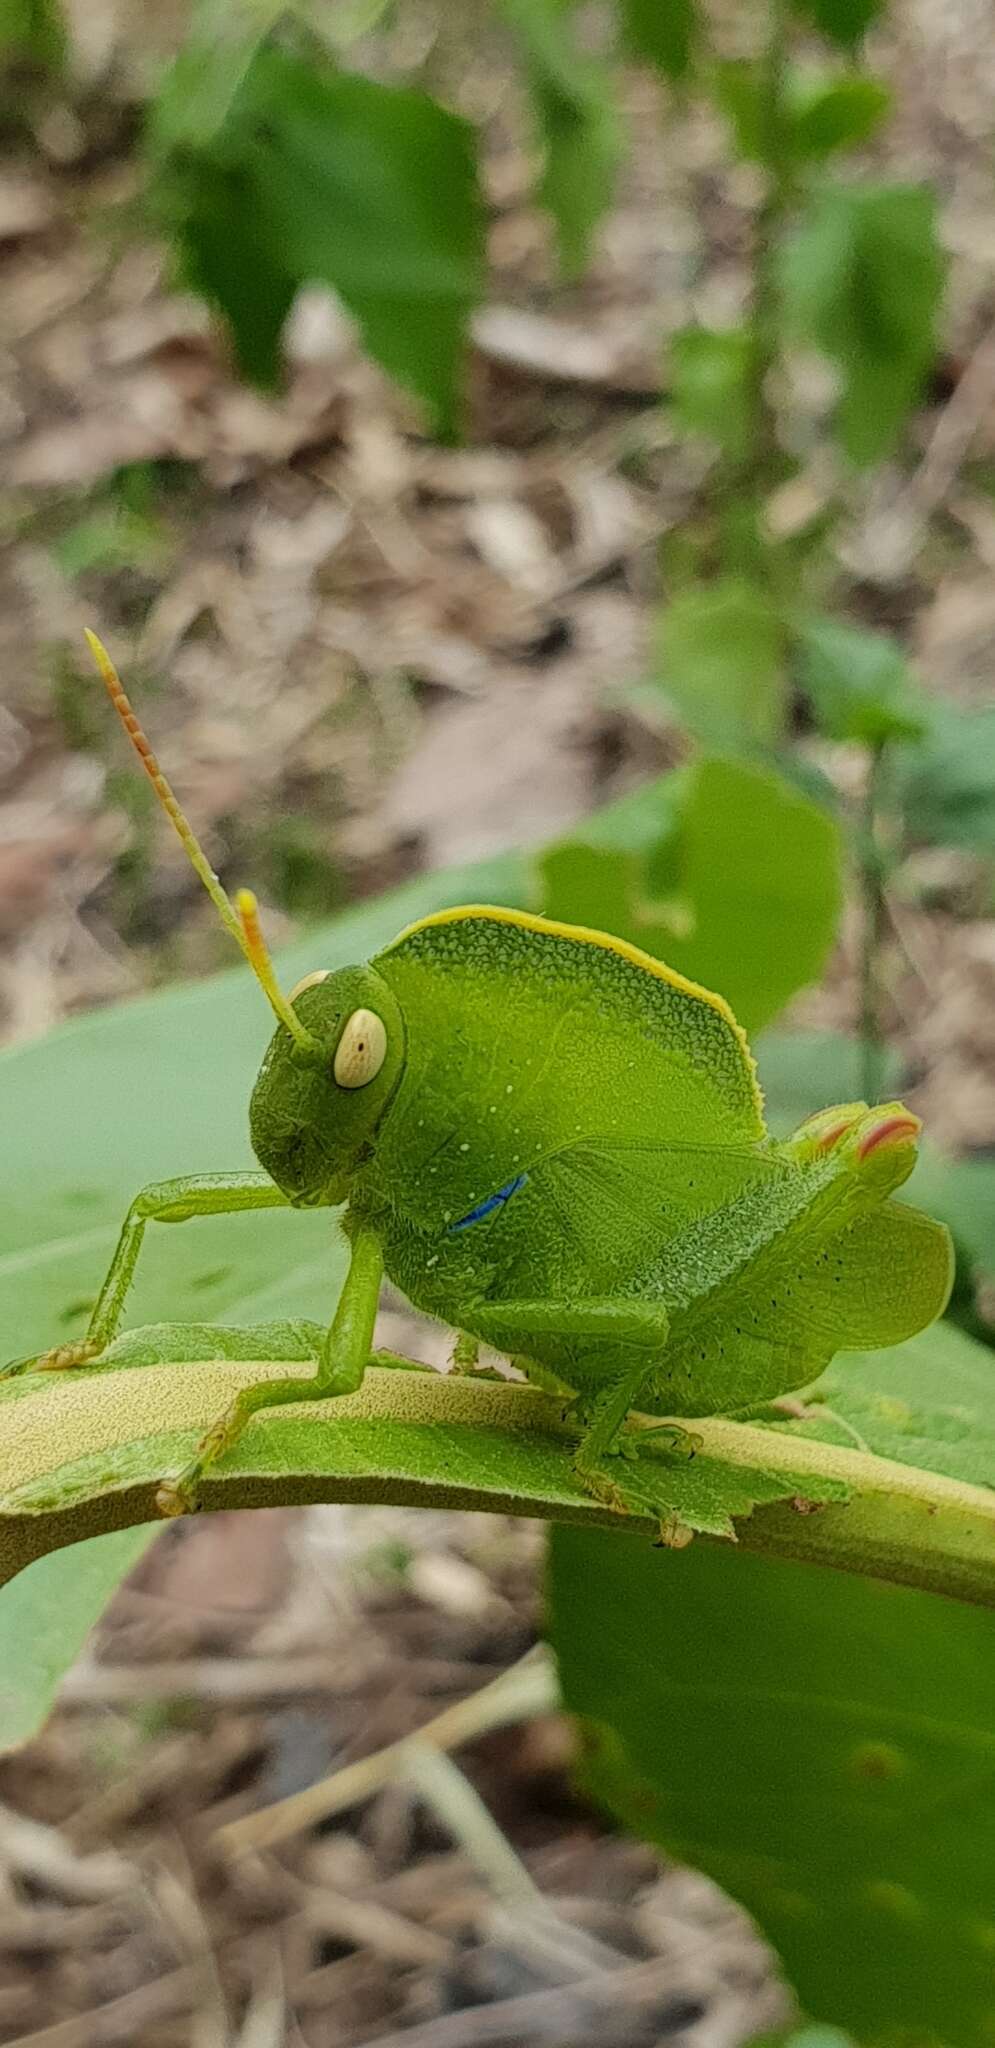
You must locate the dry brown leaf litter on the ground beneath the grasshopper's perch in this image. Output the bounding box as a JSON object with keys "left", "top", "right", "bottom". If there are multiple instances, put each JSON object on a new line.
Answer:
{"left": 0, "top": 1509, "right": 782, "bottom": 2048}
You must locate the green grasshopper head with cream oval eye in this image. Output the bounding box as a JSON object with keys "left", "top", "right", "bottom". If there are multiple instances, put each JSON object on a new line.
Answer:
{"left": 250, "top": 967, "right": 405, "bottom": 1206}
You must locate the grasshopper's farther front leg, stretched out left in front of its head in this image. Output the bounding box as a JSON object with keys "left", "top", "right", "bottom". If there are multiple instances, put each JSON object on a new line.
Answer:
{"left": 0, "top": 1171, "right": 287, "bottom": 1378}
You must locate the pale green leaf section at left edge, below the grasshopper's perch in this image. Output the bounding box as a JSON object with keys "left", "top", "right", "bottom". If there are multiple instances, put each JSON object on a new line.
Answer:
{"left": 0, "top": 1526, "right": 158, "bottom": 1751}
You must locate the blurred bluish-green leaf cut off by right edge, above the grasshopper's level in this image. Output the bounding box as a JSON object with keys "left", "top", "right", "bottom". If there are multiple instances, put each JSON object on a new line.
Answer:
{"left": 899, "top": 702, "right": 995, "bottom": 854}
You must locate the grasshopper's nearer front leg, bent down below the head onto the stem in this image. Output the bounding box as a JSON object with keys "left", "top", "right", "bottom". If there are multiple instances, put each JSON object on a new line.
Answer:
{"left": 156, "top": 1231, "right": 383, "bottom": 1516}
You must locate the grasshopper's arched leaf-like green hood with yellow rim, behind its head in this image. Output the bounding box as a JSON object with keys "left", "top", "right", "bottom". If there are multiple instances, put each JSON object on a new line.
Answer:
{"left": 375, "top": 907, "right": 766, "bottom": 1237}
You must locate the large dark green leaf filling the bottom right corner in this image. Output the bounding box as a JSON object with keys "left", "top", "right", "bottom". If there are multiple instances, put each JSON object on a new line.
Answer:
{"left": 551, "top": 1509, "right": 995, "bottom": 2048}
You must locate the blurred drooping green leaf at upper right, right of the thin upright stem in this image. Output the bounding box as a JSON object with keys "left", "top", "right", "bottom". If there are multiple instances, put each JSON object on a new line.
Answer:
{"left": 782, "top": 184, "right": 944, "bottom": 465}
